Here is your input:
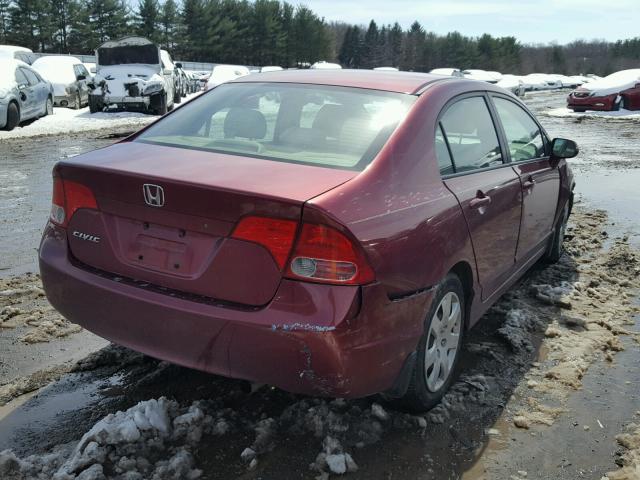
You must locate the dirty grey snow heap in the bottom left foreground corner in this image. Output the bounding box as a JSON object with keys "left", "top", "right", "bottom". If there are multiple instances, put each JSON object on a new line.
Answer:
{"left": 0, "top": 397, "right": 219, "bottom": 480}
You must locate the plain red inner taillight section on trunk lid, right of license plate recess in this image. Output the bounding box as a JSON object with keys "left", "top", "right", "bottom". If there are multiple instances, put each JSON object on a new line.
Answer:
{"left": 232, "top": 217, "right": 298, "bottom": 270}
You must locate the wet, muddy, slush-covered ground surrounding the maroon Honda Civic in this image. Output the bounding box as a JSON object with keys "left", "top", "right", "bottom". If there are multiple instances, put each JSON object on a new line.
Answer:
{"left": 0, "top": 94, "right": 640, "bottom": 480}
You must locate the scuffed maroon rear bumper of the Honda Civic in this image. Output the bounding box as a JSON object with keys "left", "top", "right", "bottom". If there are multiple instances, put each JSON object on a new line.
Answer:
{"left": 40, "top": 225, "right": 432, "bottom": 398}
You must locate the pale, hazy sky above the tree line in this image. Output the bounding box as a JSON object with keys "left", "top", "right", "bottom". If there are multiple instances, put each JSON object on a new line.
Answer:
{"left": 300, "top": 0, "right": 640, "bottom": 44}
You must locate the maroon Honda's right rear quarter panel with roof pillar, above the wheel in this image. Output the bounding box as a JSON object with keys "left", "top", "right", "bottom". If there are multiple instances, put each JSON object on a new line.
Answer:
{"left": 310, "top": 82, "right": 475, "bottom": 298}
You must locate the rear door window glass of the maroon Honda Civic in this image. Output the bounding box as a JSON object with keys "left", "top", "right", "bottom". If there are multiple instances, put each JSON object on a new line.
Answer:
{"left": 440, "top": 97, "right": 503, "bottom": 173}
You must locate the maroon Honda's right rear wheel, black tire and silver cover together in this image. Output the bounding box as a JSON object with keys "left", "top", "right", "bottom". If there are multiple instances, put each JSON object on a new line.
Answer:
{"left": 393, "top": 273, "right": 466, "bottom": 412}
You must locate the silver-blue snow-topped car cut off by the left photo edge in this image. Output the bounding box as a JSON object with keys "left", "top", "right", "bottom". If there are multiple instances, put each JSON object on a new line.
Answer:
{"left": 0, "top": 57, "right": 53, "bottom": 130}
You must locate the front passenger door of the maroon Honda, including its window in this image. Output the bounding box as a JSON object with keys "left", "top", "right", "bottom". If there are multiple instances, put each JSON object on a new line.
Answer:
{"left": 492, "top": 95, "right": 560, "bottom": 262}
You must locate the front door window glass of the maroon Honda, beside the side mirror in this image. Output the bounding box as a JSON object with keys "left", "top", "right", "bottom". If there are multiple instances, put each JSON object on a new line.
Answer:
{"left": 493, "top": 97, "right": 545, "bottom": 162}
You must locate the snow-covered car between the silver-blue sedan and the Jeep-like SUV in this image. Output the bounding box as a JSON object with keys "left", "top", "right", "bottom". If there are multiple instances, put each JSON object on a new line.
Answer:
{"left": 33, "top": 55, "right": 91, "bottom": 109}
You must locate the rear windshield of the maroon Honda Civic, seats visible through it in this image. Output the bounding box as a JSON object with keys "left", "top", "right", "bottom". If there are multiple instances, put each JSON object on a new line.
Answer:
{"left": 135, "top": 83, "right": 416, "bottom": 170}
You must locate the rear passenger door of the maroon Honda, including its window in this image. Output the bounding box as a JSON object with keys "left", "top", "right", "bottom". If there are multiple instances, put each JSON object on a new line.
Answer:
{"left": 436, "top": 94, "right": 522, "bottom": 299}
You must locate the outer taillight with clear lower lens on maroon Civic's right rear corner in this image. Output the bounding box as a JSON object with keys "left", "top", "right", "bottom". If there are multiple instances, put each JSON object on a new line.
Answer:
{"left": 286, "top": 223, "right": 375, "bottom": 285}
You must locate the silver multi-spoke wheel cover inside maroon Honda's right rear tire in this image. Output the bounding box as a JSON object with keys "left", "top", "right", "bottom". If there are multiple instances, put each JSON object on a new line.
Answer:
{"left": 424, "top": 292, "right": 462, "bottom": 392}
